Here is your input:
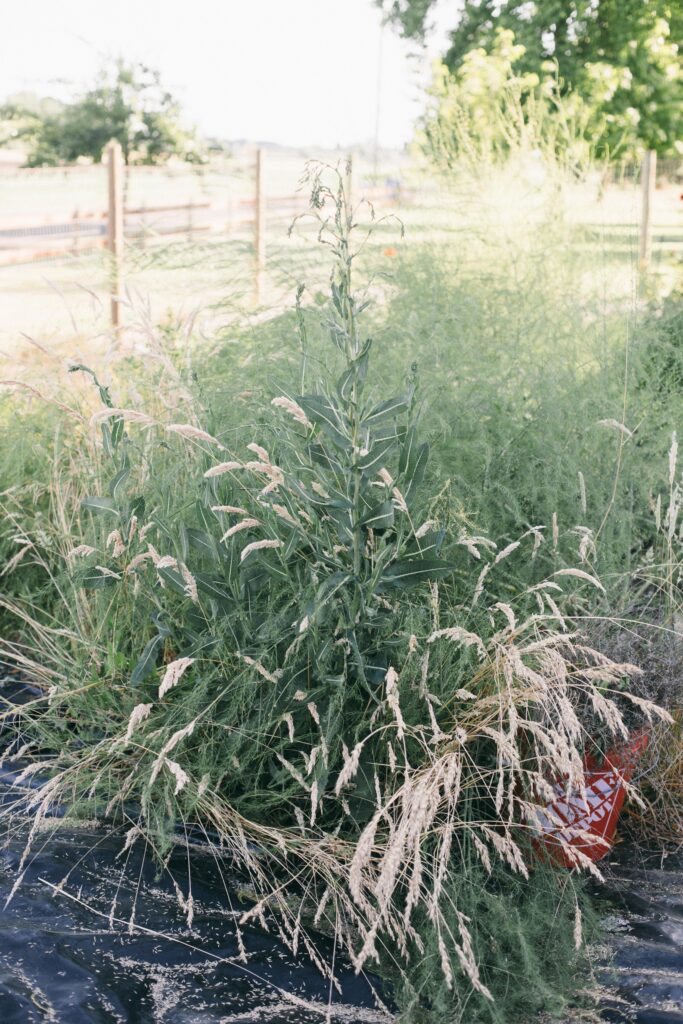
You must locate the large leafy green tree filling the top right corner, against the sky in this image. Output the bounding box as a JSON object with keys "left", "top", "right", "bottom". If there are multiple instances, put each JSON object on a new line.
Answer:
{"left": 377, "top": 0, "right": 683, "bottom": 156}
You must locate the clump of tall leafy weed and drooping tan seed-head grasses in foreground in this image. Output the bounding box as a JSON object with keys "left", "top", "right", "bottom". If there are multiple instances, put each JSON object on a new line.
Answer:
{"left": 5, "top": 163, "right": 658, "bottom": 1021}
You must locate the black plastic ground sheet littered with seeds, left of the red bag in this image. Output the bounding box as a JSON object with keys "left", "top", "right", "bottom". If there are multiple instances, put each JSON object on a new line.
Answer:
{"left": 0, "top": 820, "right": 388, "bottom": 1024}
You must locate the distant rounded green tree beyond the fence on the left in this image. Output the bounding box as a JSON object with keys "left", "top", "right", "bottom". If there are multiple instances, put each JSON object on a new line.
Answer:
{"left": 4, "top": 61, "right": 197, "bottom": 166}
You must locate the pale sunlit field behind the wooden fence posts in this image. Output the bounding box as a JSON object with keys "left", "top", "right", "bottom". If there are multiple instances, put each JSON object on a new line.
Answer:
{"left": 0, "top": 150, "right": 683, "bottom": 362}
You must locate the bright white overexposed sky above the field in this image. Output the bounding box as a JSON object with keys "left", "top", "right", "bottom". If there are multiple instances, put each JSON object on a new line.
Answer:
{"left": 5, "top": 0, "right": 459, "bottom": 146}
